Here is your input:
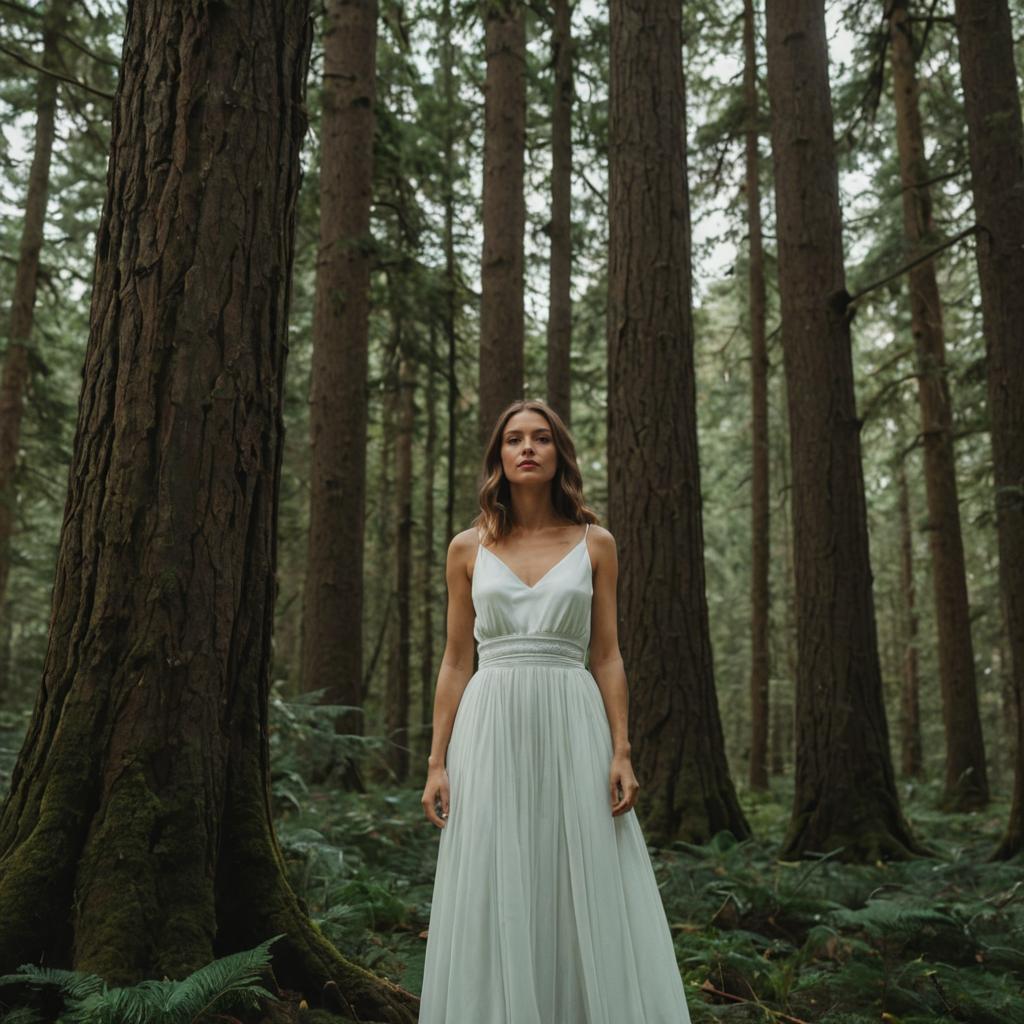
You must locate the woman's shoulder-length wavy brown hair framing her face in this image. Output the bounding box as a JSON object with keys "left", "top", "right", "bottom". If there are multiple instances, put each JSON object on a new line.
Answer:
{"left": 472, "top": 398, "right": 598, "bottom": 542}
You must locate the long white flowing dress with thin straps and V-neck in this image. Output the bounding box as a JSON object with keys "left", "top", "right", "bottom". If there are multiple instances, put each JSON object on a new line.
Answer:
{"left": 419, "top": 526, "right": 690, "bottom": 1024}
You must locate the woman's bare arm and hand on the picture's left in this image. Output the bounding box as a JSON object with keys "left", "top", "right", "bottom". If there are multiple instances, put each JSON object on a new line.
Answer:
{"left": 422, "top": 529, "right": 476, "bottom": 828}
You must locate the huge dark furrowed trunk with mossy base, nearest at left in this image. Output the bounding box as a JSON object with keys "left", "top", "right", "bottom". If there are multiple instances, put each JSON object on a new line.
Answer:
{"left": 0, "top": 0, "right": 416, "bottom": 1021}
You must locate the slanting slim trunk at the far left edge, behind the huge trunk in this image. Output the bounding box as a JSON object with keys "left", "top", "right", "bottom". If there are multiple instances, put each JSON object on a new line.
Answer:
{"left": 0, "top": 0, "right": 70, "bottom": 638}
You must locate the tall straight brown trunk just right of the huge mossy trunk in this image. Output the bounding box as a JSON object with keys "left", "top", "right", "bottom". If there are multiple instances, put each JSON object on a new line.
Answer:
{"left": 302, "top": 0, "right": 377, "bottom": 733}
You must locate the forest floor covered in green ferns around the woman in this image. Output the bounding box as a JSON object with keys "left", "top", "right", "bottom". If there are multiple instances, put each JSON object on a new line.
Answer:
{"left": 0, "top": 698, "right": 1024, "bottom": 1024}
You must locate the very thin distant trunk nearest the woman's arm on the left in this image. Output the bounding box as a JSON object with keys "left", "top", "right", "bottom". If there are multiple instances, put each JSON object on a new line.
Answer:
{"left": 418, "top": 322, "right": 443, "bottom": 771}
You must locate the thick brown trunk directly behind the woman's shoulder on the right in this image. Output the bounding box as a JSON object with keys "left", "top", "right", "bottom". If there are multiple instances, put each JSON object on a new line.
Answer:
{"left": 607, "top": 0, "right": 750, "bottom": 844}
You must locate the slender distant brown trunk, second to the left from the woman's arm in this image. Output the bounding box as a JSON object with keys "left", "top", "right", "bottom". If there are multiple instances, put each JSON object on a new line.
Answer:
{"left": 386, "top": 315, "right": 416, "bottom": 782}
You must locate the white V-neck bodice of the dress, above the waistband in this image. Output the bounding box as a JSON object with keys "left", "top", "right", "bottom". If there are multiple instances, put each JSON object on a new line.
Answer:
{"left": 471, "top": 523, "right": 594, "bottom": 651}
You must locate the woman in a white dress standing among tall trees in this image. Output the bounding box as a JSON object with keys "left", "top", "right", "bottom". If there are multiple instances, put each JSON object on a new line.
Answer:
{"left": 419, "top": 401, "right": 690, "bottom": 1024}
